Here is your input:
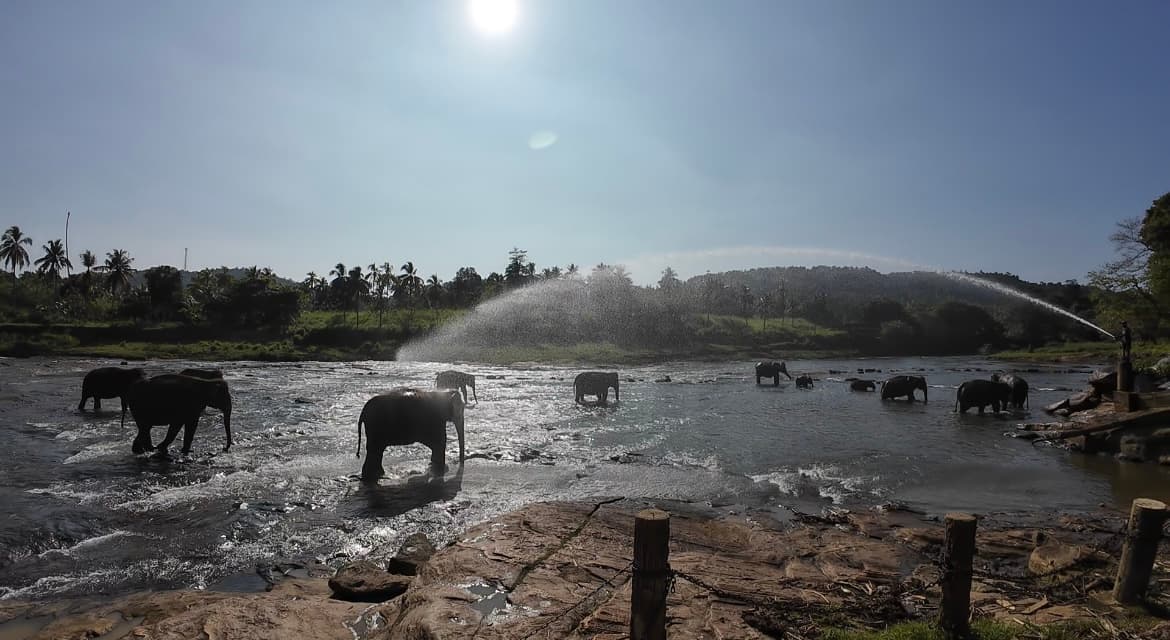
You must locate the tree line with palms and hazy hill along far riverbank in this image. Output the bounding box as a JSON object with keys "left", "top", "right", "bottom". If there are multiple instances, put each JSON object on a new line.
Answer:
{"left": 0, "top": 194, "right": 1170, "bottom": 355}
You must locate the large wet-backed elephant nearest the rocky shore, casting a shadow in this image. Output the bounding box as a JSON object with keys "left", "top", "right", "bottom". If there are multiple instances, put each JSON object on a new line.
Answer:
{"left": 357, "top": 387, "right": 466, "bottom": 482}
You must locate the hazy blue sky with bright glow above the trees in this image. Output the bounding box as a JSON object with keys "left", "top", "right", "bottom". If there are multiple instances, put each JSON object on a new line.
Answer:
{"left": 0, "top": 0, "right": 1170, "bottom": 282}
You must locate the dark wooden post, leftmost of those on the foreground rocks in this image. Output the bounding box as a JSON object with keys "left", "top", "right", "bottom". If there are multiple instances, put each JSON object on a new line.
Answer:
{"left": 629, "top": 509, "right": 670, "bottom": 640}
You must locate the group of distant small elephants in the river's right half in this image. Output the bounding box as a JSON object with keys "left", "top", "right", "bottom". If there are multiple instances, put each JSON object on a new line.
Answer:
{"left": 756, "top": 360, "right": 1028, "bottom": 413}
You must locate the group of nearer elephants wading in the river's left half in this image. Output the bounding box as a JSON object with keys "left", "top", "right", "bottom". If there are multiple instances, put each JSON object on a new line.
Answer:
{"left": 77, "top": 366, "right": 620, "bottom": 481}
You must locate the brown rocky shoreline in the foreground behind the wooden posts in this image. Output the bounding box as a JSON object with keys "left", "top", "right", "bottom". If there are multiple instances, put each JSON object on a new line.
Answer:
{"left": 0, "top": 498, "right": 1170, "bottom": 640}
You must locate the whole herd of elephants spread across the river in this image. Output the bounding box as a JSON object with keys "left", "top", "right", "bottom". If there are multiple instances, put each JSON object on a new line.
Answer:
{"left": 77, "top": 360, "right": 1028, "bottom": 481}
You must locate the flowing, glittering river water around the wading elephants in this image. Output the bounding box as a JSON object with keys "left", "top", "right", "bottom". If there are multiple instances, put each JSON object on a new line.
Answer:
{"left": 0, "top": 358, "right": 1170, "bottom": 599}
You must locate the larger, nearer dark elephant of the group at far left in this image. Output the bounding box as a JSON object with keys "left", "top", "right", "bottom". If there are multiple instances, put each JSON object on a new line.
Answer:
{"left": 122, "top": 373, "right": 232, "bottom": 457}
